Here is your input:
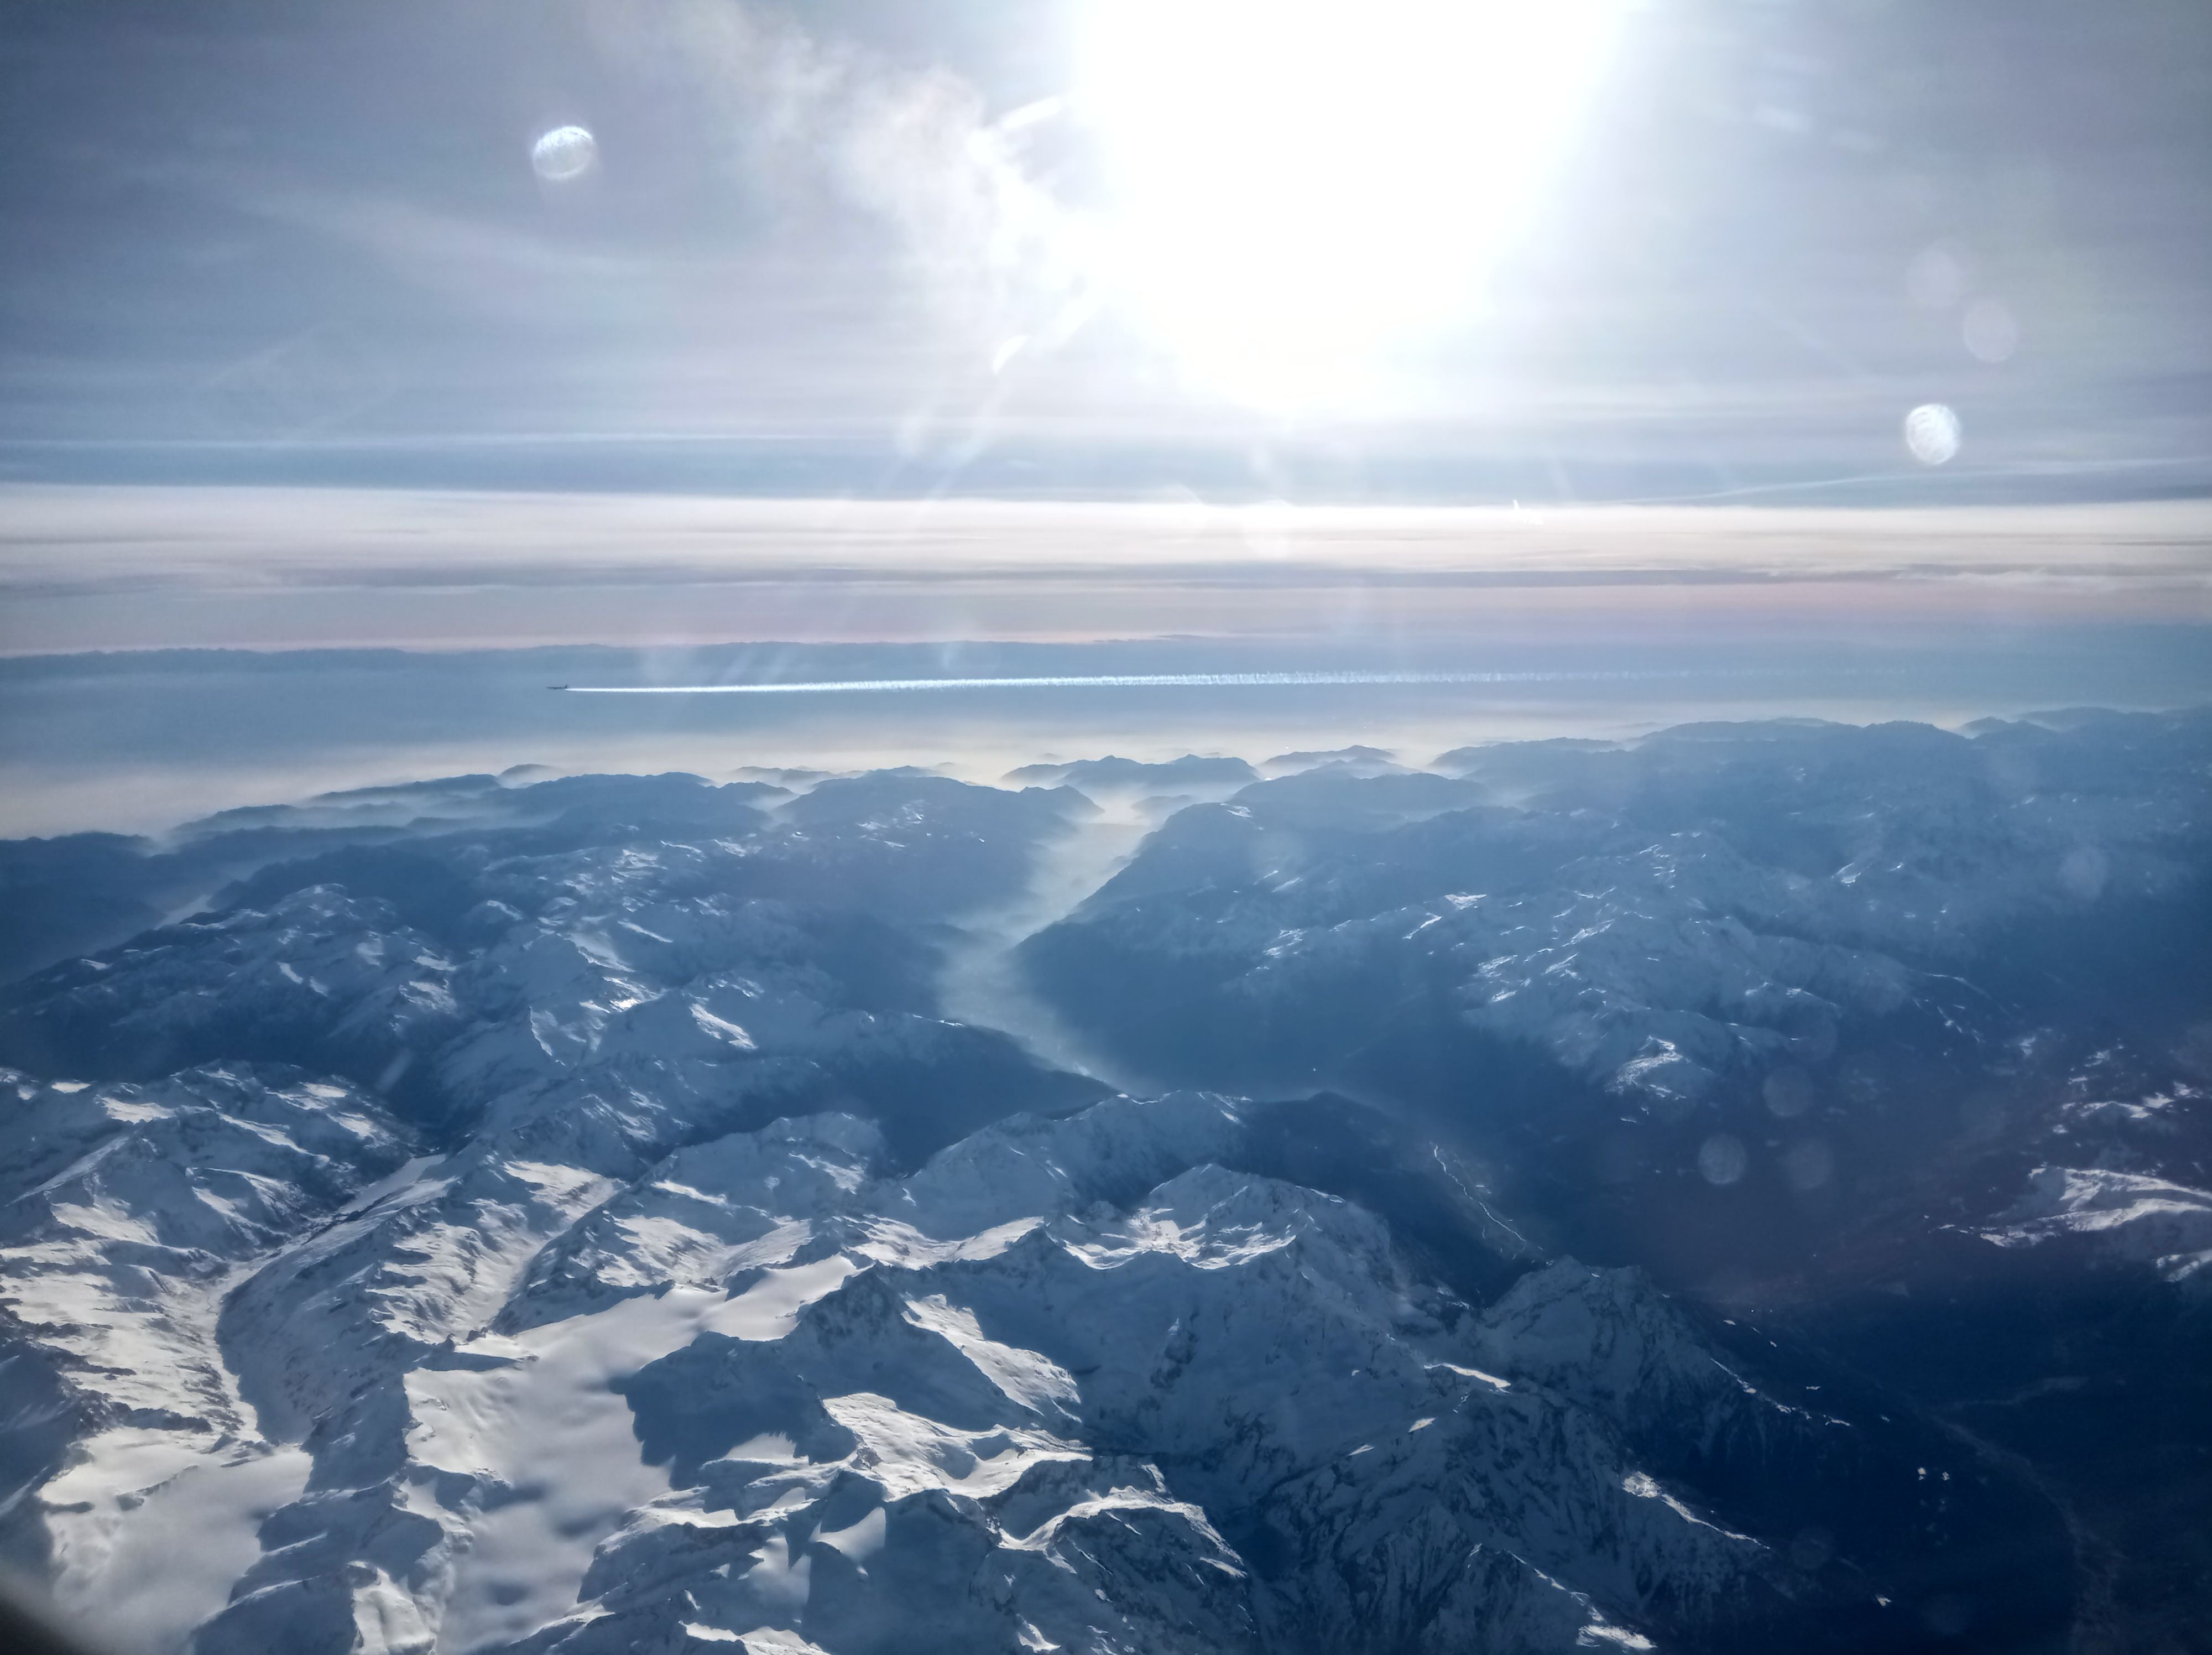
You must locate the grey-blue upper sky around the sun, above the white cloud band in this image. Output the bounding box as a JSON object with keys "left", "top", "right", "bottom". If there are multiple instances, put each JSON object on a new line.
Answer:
{"left": 0, "top": 0, "right": 2212, "bottom": 504}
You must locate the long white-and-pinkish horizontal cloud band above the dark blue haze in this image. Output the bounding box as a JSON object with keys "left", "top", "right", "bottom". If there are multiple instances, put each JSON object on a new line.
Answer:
{"left": 0, "top": 487, "right": 2212, "bottom": 655}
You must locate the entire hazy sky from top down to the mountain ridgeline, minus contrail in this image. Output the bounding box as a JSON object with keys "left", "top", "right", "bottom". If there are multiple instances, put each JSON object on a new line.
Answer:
{"left": 0, "top": 0, "right": 2212, "bottom": 832}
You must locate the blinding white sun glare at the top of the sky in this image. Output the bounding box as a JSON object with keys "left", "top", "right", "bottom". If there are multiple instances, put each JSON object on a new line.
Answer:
{"left": 1082, "top": 0, "right": 1619, "bottom": 405}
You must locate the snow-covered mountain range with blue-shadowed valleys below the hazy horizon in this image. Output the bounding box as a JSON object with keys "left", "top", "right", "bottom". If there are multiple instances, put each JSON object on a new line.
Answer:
{"left": 0, "top": 715, "right": 2212, "bottom": 1655}
